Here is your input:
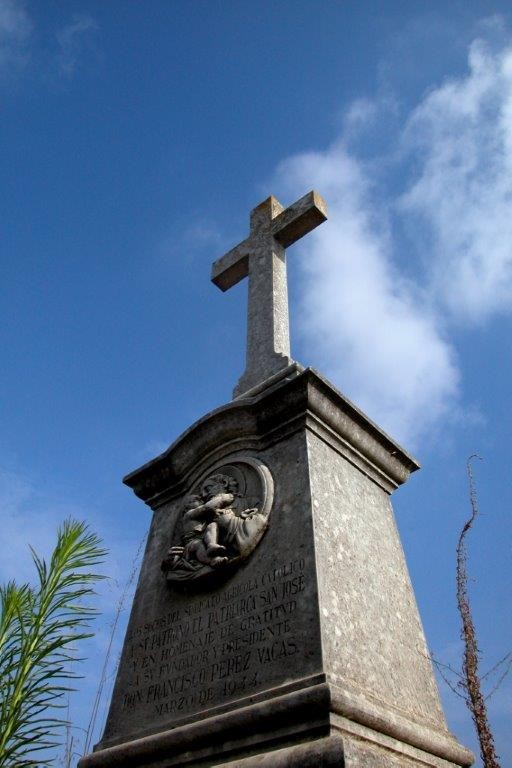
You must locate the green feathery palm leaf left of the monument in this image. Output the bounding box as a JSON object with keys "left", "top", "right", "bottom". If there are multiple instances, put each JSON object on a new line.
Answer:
{"left": 0, "top": 520, "right": 106, "bottom": 768}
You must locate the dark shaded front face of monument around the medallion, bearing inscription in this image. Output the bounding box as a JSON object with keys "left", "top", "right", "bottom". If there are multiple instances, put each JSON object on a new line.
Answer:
{"left": 103, "top": 426, "right": 322, "bottom": 743}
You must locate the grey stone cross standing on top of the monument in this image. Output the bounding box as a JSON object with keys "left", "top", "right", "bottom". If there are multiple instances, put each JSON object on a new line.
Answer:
{"left": 212, "top": 192, "right": 327, "bottom": 397}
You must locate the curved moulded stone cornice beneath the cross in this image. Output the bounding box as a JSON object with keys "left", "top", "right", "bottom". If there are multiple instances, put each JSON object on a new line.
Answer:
{"left": 123, "top": 368, "right": 419, "bottom": 508}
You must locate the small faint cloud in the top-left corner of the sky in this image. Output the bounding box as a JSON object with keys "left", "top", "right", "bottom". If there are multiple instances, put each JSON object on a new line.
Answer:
{"left": 0, "top": 0, "right": 32, "bottom": 76}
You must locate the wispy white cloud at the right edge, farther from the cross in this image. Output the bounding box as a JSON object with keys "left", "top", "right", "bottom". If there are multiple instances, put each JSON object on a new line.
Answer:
{"left": 400, "top": 40, "right": 512, "bottom": 322}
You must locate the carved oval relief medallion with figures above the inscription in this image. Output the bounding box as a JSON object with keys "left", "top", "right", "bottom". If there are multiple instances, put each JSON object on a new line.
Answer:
{"left": 162, "top": 457, "right": 274, "bottom": 582}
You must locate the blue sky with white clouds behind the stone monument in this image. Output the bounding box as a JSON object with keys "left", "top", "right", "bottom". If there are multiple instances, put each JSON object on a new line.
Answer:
{"left": 0, "top": 0, "right": 512, "bottom": 765}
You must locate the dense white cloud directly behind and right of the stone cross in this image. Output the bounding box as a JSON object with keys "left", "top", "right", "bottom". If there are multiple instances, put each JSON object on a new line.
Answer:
{"left": 277, "top": 143, "right": 458, "bottom": 442}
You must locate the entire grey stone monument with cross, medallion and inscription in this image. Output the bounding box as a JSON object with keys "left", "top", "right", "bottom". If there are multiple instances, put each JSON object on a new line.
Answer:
{"left": 80, "top": 192, "right": 473, "bottom": 768}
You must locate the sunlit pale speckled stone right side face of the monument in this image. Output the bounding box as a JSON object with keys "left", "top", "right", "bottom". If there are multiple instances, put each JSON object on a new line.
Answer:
{"left": 307, "top": 432, "right": 444, "bottom": 728}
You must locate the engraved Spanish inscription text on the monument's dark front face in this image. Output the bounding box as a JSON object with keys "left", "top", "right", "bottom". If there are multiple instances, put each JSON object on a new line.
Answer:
{"left": 123, "top": 559, "right": 306, "bottom": 716}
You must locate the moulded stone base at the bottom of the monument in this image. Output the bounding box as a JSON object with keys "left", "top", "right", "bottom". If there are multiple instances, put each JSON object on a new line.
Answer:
{"left": 80, "top": 675, "right": 473, "bottom": 768}
